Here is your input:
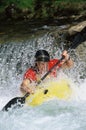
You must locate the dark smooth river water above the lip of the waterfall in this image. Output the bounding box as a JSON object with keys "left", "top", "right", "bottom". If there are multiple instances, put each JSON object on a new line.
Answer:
{"left": 0, "top": 9, "right": 86, "bottom": 43}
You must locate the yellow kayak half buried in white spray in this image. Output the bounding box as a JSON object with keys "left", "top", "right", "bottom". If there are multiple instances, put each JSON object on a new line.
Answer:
{"left": 26, "top": 80, "right": 72, "bottom": 106}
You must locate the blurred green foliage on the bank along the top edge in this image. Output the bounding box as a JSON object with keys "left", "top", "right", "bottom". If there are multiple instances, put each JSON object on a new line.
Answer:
{"left": 0, "top": 0, "right": 86, "bottom": 17}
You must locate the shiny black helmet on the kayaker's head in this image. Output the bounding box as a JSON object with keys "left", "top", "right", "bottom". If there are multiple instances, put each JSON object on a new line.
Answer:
{"left": 35, "top": 50, "right": 50, "bottom": 62}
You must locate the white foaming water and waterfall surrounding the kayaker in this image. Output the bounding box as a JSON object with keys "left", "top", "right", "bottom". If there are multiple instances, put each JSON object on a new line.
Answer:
{"left": 0, "top": 30, "right": 86, "bottom": 130}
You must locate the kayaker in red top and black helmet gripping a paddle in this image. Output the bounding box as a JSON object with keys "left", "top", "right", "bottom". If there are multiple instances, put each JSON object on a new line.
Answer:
{"left": 20, "top": 50, "right": 73, "bottom": 93}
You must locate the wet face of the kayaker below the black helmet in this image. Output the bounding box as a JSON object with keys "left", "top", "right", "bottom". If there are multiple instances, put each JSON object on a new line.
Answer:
{"left": 37, "top": 61, "right": 48, "bottom": 74}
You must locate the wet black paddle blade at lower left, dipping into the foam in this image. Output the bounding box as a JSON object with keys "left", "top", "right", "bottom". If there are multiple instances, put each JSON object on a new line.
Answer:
{"left": 2, "top": 97, "right": 25, "bottom": 111}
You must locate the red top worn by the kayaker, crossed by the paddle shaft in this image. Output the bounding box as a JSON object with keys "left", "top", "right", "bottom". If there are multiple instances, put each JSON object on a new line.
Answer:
{"left": 24, "top": 59, "right": 61, "bottom": 81}
